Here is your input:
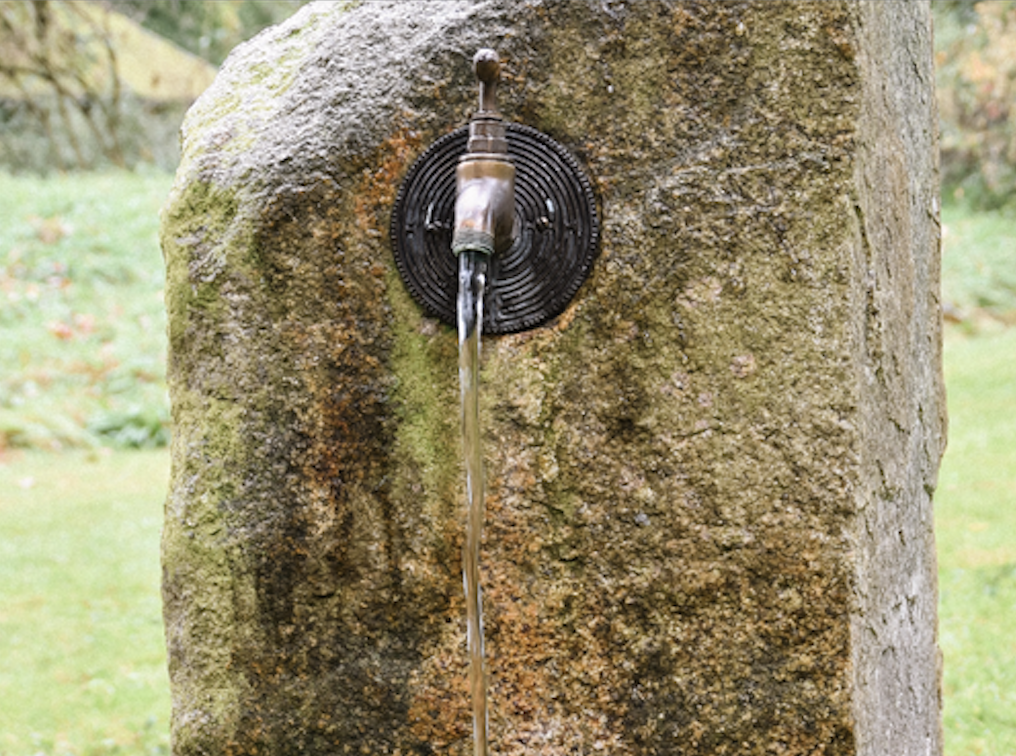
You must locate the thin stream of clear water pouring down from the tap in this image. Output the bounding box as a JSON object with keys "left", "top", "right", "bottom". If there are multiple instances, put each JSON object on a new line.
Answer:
{"left": 457, "top": 252, "right": 489, "bottom": 756}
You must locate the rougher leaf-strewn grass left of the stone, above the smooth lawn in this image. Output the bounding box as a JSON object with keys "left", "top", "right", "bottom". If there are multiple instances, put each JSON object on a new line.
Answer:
{"left": 0, "top": 173, "right": 172, "bottom": 449}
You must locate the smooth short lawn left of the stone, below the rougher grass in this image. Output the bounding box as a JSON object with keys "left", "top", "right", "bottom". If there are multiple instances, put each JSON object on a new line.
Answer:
{"left": 0, "top": 450, "right": 169, "bottom": 756}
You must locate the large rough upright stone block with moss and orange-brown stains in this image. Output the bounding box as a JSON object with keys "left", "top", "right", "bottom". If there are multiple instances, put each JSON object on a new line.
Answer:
{"left": 163, "top": 0, "right": 944, "bottom": 756}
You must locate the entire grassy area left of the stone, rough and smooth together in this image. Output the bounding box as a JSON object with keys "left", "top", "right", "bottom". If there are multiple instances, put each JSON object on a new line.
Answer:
{"left": 0, "top": 173, "right": 172, "bottom": 756}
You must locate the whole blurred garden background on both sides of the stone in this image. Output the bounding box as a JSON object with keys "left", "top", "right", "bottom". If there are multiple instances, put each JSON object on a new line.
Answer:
{"left": 0, "top": 0, "right": 1016, "bottom": 756}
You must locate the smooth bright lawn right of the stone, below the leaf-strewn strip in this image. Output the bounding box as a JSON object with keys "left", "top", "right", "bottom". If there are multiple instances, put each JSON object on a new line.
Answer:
{"left": 935, "top": 328, "right": 1016, "bottom": 756}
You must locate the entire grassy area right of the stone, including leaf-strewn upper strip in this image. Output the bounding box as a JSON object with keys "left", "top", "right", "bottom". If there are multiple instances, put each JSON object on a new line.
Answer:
{"left": 935, "top": 203, "right": 1016, "bottom": 756}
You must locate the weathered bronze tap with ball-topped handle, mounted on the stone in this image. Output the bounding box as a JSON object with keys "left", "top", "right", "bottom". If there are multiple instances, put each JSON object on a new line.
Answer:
{"left": 451, "top": 50, "right": 515, "bottom": 255}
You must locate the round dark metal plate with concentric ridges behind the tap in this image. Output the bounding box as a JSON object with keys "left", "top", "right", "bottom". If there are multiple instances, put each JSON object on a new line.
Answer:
{"left": 391, "top": 123, "right": 599, "bottom": 333}
